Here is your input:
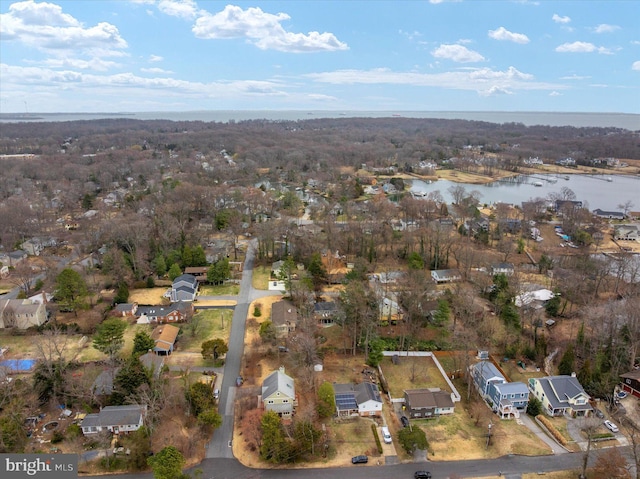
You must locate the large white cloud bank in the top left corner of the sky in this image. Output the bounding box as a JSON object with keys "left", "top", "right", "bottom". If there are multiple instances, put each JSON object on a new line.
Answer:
{"left": 0, "top": 1, "right": 127, "bottom": 58}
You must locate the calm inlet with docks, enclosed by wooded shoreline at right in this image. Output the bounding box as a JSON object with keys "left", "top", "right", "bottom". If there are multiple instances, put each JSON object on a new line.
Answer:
{"left": 409, "top": 175, "right": 640, "bottom": 211}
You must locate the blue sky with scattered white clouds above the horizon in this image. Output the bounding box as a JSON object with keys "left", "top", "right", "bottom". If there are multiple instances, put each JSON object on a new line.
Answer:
{"left": 0, "top": 0, "right": 640, "bottom": 113}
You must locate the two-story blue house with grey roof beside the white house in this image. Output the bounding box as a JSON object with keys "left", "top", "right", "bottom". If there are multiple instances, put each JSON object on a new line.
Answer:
{"left": 470, "top": 361, "right": 529, "bottom": 419}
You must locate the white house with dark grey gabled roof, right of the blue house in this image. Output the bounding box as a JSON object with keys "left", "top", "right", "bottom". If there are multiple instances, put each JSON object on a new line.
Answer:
{"left": 529, "top": 374, "right": 593, "bottom": 417}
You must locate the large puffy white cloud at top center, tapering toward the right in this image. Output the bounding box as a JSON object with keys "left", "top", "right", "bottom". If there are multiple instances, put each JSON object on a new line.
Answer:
{"left": 192, "top": 5, "right": 348, "bottom": 53}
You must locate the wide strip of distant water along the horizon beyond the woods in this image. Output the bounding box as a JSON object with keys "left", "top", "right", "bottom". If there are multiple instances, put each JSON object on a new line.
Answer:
{"left": 0, "top": 110, "right": 640, "bottom": 131}
